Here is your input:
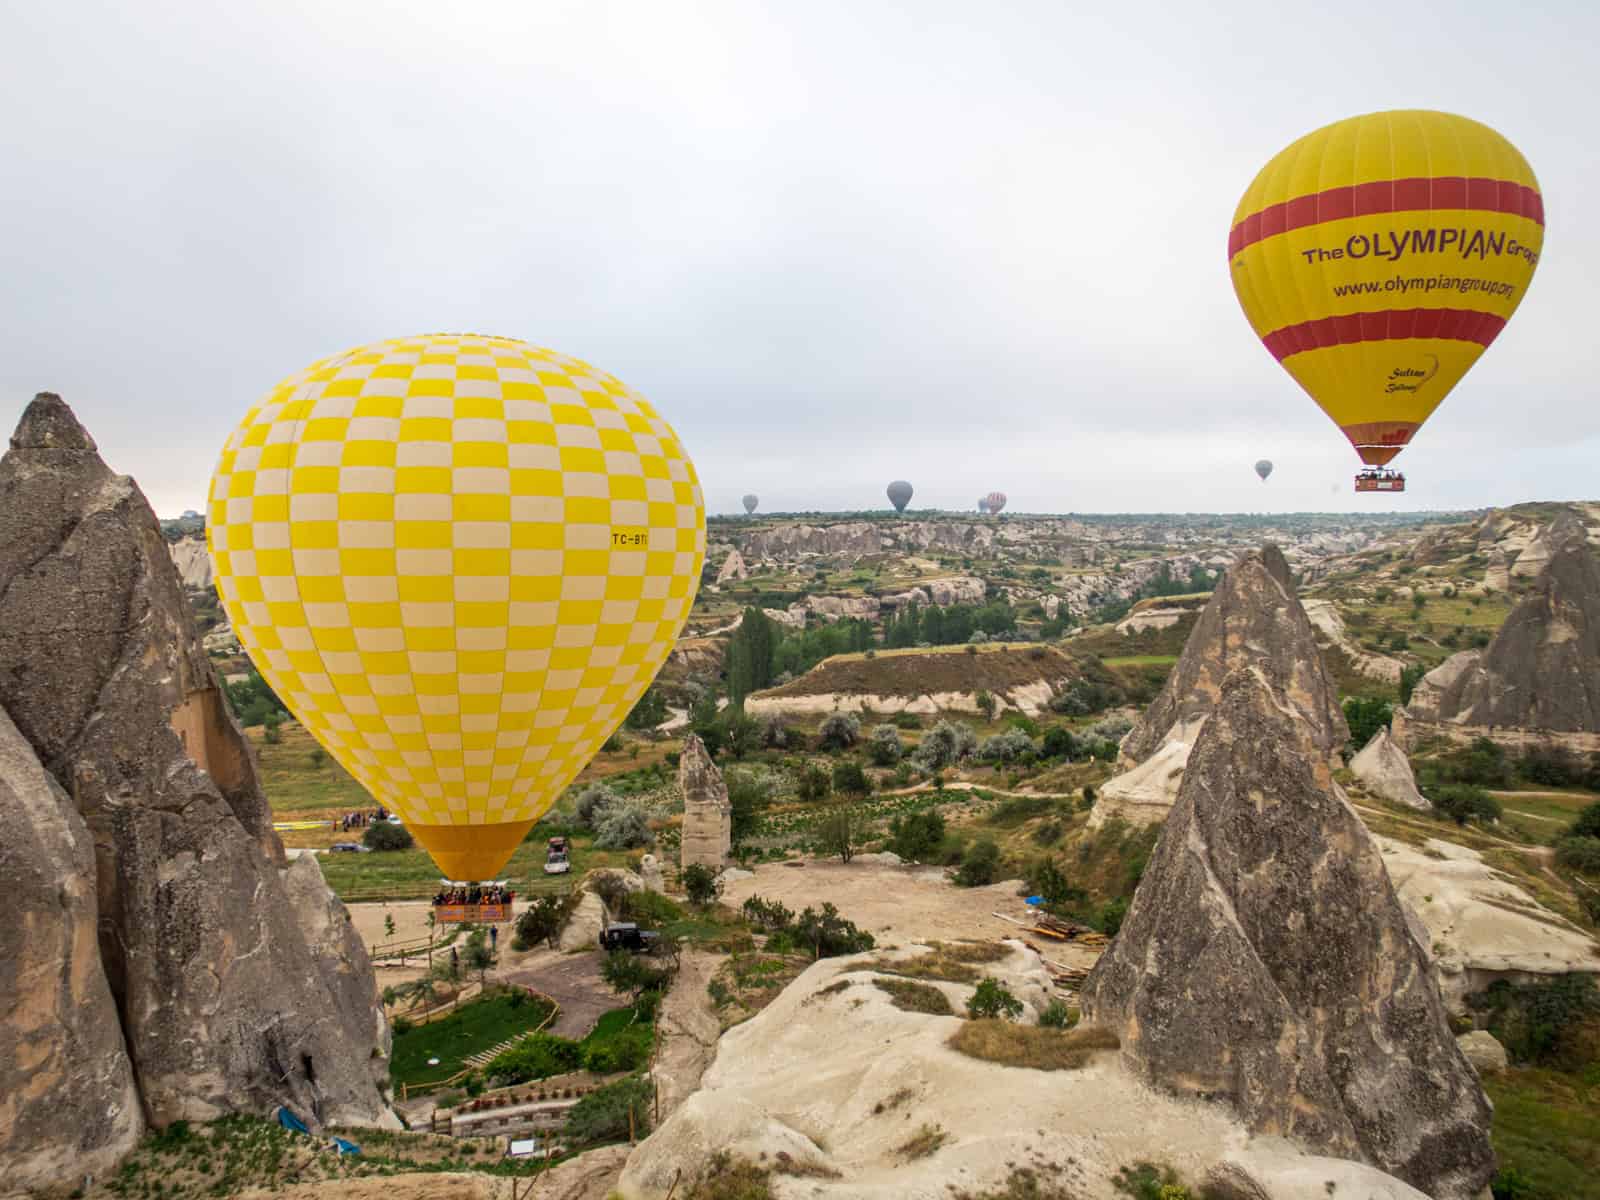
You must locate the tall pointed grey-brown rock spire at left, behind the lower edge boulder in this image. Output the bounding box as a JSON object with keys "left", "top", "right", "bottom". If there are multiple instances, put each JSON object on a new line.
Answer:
{"left": 0, "top": 395, "right": 394, "bottom": 1184}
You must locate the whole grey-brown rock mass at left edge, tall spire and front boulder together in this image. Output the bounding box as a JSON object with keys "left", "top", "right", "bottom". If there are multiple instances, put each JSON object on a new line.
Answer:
{"left": 0, "top": 395, "right": 395, "bottom": 1186}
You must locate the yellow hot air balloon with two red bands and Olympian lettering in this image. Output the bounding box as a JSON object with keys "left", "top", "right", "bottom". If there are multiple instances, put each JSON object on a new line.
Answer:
{"left": 1227, "top": 110, "right": 1544, "bottom": 490}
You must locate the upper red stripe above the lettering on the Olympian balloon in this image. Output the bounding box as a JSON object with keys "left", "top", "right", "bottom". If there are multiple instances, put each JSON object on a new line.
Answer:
{"left": 1227, "top": 174, "right": 1544, "bottom": 258}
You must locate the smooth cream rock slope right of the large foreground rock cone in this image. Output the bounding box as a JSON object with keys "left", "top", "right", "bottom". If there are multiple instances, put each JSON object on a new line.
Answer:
{"left": 1378, "top": 837, "right": 1600, "bottom": 1014}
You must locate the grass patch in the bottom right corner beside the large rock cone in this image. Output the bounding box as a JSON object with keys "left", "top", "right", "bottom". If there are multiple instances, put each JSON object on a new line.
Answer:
{"left": 1483, "top": 1064, "right": 1600, "bottom": 1200}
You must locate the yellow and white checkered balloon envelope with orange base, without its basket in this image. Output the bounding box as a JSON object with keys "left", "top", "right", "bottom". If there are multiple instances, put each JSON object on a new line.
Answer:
{"left": 206, "top": 334, "right": 706, "bottom": 878}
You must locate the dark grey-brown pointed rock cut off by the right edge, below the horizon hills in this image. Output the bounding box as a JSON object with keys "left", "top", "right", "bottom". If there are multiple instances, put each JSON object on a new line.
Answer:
{"left": 1395, "top": 514, "right": 1600, "bottom": 750}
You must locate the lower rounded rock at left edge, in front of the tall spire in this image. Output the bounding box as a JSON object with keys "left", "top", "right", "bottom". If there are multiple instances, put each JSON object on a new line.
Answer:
{"left": 0, "top": 709, "right": 144, "bottom": 1190}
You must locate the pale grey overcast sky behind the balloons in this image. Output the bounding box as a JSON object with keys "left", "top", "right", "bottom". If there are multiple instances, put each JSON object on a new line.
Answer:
{"left": 0, "top": 0, "right": 1600, "bottom": 515}
